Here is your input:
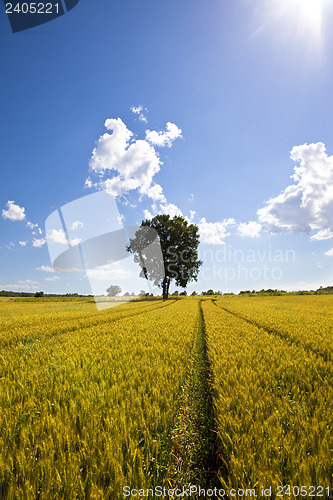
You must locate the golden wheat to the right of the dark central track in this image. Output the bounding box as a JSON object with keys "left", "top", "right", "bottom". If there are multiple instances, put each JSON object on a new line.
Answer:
{"left": 203, "top": 297, "right": 333, "bottom": 491}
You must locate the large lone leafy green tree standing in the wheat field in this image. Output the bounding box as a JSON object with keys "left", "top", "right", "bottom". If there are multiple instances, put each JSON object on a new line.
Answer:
{"left": 128, "top": 214, "right": 202, "bottom": 300}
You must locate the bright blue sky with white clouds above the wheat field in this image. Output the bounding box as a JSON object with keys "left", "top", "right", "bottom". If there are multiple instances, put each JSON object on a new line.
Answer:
{"left": 0, "top": 0, "right": 333, "bottom": 293}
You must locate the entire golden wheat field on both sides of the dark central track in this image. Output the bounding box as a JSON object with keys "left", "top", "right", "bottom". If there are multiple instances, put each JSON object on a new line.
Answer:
{"left": 0, "top": 296, "right": 333, "bottom": 500}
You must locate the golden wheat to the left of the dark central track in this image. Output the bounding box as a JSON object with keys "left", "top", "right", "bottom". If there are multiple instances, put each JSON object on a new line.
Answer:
{"left": 0, "top": 301, "right": 198, "bottom": 498}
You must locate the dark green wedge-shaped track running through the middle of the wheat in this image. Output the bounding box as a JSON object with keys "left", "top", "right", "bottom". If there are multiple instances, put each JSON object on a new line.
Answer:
{"left": 169, "top": 302, "right": 219, "bottom": 492}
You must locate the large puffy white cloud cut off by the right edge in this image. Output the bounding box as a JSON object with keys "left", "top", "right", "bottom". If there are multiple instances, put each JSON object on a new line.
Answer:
{"left": 258, "top": 142, "right": 333, "bottom": 239}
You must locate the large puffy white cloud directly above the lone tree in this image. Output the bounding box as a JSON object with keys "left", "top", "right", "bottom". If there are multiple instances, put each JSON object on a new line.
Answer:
{"left": 86, "top": 118, "right": 182, "bottom": 226}
